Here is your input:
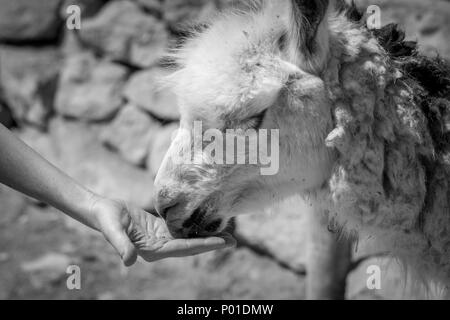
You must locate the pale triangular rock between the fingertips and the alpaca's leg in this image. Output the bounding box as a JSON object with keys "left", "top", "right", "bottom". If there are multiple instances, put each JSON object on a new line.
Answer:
{"left": 236, "top": 198, "right": 308, "bottom": 272}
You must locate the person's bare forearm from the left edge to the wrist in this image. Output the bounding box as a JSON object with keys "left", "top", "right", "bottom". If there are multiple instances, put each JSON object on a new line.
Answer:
{"left": 0, "top": 124, "right": 98, "bottom": 230}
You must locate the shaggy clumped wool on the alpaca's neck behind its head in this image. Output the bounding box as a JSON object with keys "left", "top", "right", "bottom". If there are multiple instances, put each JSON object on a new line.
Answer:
{"left": 324, "top": 3, "right": 450, "bottom": 283}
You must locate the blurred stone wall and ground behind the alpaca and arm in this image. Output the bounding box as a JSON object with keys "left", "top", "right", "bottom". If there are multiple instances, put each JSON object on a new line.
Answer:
{"left": 0, "top": 0, "right": 450, "bottom": 299}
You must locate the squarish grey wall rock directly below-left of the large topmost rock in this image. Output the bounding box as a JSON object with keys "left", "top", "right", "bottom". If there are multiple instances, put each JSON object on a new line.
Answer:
{"left": 55, "top": 53, "right": 128, "bottom": 121}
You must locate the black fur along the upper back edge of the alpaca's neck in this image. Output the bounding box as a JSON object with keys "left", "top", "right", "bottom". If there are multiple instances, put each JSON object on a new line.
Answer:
{"left": 339, "top": 1, "right": 450, "bottom": 156}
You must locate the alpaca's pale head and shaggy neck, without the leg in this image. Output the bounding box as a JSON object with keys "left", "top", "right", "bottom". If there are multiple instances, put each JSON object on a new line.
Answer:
{"left": 155, "top": 0, "right": 450, "bottom": 296}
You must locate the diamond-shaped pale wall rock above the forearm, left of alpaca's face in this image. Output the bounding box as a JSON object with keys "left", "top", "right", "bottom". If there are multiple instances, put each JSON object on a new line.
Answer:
{"left": 100, "top": 104, "right": 159, "bottom": 166}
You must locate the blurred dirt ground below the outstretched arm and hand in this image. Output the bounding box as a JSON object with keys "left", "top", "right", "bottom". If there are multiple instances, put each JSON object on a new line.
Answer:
{"left": 0, "top": 188, "right": 304, "bottom": 299}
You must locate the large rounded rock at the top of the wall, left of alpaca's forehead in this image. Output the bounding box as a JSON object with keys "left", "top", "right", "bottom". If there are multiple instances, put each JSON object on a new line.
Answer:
{"left": 79, "top": 1, "right": 168, "bottom": 67}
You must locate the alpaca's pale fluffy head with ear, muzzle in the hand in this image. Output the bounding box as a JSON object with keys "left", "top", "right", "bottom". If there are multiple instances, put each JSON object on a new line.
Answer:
{"left": 155, "top": 0, "right": 333, "bottom": 237}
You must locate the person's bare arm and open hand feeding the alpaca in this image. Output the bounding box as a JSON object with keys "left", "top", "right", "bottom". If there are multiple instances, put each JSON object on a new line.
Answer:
{"left": 0, "top": 124, "right": 234, "bottom": 266}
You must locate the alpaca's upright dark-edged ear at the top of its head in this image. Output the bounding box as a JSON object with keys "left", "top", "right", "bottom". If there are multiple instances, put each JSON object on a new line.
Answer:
{"left": 290, "top": 0, "right": 329, "bottom": 73}
